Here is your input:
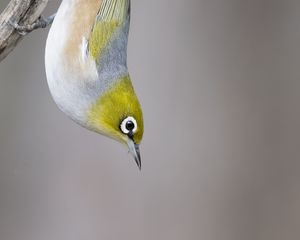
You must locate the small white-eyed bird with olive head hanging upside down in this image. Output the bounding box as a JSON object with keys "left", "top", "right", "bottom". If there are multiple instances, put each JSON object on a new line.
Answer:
{"left": 45, "top": 0, "right": 144, "bottom": 169}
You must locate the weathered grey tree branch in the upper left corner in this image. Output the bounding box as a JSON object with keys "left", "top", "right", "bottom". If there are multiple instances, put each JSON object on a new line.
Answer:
{"left": 0, "top": 0, "right": 48, "bottom": 62}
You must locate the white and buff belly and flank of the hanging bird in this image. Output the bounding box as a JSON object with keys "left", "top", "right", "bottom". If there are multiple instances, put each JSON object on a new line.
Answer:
{"left": 45, "top": 0, "right": 98, "bottom": 127}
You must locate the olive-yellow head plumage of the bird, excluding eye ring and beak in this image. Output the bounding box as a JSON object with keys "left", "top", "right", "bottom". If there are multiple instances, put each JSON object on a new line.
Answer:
{"left": 88, "top": 75, "right": 144, "bottom": 144}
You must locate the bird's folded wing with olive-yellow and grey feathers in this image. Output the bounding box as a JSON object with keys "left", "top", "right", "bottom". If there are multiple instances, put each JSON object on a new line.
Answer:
{"left": 88, "top": 0, "right": 130, "bottom": 63}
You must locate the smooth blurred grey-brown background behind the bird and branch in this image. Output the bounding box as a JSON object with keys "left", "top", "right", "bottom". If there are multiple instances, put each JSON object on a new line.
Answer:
{"left": 0, "top": 0, "right": 300, "bottom": 240}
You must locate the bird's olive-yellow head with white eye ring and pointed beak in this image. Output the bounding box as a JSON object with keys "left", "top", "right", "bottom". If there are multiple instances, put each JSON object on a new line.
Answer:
{"left": 88, "top": 75, "right": 144, "bottom": 168}
